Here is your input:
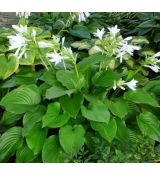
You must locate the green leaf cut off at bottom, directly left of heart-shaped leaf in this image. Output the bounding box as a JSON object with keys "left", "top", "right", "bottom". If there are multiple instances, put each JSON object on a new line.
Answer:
{"left": 42, "top": 136, "right": 64, "bottom": 163}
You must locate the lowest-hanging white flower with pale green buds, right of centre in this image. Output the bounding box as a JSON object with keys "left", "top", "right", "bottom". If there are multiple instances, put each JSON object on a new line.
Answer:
{"left": 113, "top": 79, "right": 138, "bottom": 91}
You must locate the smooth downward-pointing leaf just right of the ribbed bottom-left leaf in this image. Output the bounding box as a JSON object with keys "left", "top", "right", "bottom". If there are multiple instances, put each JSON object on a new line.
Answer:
{"left": 24, "top": 123, "right": 47, "bottom": 155}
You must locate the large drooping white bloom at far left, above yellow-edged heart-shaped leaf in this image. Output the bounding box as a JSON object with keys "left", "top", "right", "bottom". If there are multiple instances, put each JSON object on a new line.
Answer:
{"left": 8, "top": 34, "right": 28, "bottom": 59}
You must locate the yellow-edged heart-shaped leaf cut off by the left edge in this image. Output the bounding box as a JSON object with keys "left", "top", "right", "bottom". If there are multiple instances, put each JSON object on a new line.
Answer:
{"left": 0, "top": 54, "right": 19, "bottom": 80}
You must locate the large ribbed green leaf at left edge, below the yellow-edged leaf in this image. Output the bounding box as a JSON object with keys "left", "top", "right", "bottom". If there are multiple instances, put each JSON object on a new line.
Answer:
{"left": 0, "top": 85, "right": 41, "bottom": 114}
